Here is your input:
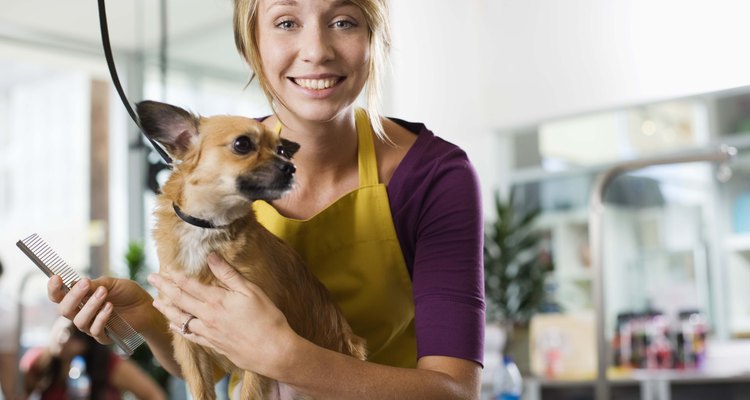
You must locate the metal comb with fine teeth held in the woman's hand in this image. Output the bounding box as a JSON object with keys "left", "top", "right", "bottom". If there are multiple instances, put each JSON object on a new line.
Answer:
{"left": 16, "top": 233, "right": 144, "bottom": 355}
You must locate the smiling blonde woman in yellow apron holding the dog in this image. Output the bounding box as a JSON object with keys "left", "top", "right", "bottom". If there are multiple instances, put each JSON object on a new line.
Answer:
{"left": 48, "top": 0, "right": 484, "bottom": 399}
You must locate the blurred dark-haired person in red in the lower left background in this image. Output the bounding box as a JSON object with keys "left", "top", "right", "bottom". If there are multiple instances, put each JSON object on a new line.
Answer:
{"left": 21, "top": 318, "right": 166, "bottom": 400}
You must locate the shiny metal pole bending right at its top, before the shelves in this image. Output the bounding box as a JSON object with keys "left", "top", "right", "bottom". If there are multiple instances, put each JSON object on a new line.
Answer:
{"left": 589, "top": 146, "right": 737, "bottom": 400}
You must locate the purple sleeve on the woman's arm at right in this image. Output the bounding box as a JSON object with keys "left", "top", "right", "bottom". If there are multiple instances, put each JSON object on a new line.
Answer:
{"left": 388, "top": 126, "right": 485, "bottom": 364}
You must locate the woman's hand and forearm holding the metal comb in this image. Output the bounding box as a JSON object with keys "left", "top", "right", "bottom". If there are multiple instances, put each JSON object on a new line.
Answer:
{"left": 47, "top": 275, "right": 180, "bottom": 376}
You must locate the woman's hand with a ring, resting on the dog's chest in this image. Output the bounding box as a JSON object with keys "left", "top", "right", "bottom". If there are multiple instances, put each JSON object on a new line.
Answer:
{"left": 149, "top": 254, "right": 298, "bottom": 377}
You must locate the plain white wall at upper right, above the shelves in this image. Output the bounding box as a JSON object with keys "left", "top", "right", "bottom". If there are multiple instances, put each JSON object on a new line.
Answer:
{"left": 387, "top": 0, "right": 750, "bottom": 212}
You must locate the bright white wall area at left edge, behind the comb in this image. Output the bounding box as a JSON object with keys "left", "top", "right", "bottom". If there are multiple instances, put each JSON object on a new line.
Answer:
{"left": 0, "top": 65, "right": 91, "bottom": 302}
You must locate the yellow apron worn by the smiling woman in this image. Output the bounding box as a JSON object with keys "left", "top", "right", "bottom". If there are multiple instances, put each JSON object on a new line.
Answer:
{"left": 230, "top": 109, "right": 417, "bottom": 392}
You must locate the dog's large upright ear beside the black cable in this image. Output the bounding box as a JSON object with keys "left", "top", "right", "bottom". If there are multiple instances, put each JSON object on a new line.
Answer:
{"left": 136, "top": 100, "right": 198, "bottom": 159}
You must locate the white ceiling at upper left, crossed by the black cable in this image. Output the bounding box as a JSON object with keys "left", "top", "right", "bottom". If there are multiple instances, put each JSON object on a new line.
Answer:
{"left": 0, "top": 0, "right": 247, "bottom": 80}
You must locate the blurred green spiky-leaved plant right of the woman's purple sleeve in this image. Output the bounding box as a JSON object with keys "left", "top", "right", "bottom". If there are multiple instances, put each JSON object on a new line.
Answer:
{"left": 484, "top": 190, "right": 553, "bottom": 373}
